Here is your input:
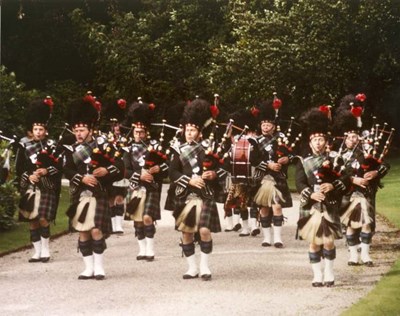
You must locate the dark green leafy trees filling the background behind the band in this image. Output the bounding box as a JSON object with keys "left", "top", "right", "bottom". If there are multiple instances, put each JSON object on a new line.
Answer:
{"left": 0, "top": 0, "right": 400, "bottom": 141}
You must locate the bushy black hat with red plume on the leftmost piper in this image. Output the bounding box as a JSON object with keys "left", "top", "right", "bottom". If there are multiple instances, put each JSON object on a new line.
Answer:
{"left": 26, "top": 96, "right": 54, "bottom": 130}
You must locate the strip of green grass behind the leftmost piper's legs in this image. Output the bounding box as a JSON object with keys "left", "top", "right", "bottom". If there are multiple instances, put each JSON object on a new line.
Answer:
{"left": 0, "top": 187, "right": 69, "bottom": 256}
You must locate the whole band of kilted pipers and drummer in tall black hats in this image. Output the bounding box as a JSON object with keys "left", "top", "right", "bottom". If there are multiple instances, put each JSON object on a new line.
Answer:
{"left": 5, "top": 90, "right": 392, "bottom": 286}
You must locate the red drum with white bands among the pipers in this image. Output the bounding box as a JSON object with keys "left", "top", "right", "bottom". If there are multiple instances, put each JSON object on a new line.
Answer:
{"left": 231, "top": 137, "right": 251, "bottom": 184}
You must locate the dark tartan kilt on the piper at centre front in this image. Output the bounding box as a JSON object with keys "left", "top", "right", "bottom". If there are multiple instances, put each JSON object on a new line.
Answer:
{"left": 175, "top": 196, "right": 221, "bottom": 233}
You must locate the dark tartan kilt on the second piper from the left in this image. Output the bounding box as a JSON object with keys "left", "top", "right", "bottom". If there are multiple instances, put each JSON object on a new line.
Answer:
{"left": 71, "top": 190, "right": 111, "bottom": 238}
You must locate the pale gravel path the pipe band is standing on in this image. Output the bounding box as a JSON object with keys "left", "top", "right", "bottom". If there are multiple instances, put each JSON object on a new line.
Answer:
{"left": 0, "top": 188, "right": 400, "bottom": 316}
